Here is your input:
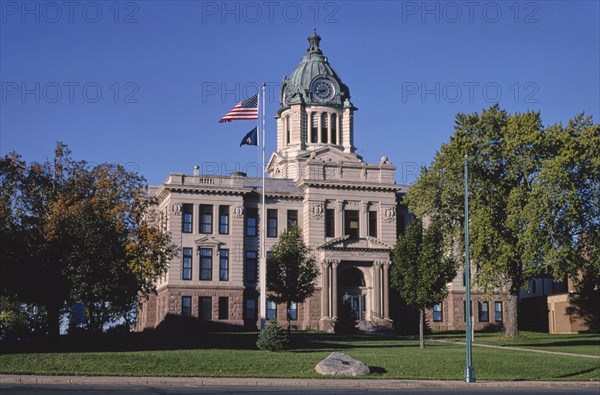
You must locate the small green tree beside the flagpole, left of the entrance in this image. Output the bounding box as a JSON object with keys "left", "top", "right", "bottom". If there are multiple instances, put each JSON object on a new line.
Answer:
{"left": 267, "top": 227, "right": 319, "bottom": 332}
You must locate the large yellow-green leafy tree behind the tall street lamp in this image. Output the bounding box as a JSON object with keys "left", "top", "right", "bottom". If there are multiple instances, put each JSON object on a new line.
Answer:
{"left": 407, "top": 105, "right": 600, "bottom": 336}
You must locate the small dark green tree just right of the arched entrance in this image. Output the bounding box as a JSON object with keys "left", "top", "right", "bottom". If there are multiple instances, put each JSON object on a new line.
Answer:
{"left": 391, "top": 218, "right": 456, "bottom": 348}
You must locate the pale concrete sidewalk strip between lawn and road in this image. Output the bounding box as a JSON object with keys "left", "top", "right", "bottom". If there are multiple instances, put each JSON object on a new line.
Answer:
{"left": 0, "top": 375, "right": 600, "bottom": 390}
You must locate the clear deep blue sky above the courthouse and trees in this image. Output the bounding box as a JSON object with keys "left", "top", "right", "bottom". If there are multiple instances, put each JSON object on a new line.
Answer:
{"left": 0, "top": 0, "right": 600, "bottom": 185}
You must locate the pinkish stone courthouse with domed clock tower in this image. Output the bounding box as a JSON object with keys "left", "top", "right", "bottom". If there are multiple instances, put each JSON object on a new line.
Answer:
{"left": 136, "top": 33, "right": 510, "bottom": 330}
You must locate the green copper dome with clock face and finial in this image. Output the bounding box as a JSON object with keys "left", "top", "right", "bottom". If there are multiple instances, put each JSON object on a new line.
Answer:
{"left": 281, "top": 31, "right": 350, "bottom": 107}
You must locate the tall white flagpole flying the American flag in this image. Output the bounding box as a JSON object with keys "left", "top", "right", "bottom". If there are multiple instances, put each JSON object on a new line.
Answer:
{"left": 258, "top": 83, "right": 267, "bottom": 331}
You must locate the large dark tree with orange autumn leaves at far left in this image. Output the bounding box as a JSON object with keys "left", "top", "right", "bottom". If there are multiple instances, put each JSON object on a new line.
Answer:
{"left": 0, "top": 143, "right": 176, "bottom": 335}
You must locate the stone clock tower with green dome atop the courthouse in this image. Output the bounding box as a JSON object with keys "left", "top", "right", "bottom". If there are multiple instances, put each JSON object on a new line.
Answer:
{"left": 267, "top": 31, "right": 362, "bottom": 179}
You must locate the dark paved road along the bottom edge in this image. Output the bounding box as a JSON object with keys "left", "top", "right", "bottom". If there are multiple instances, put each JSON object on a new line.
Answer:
{"left": 0, "top": 384, "right": 599, "bottom": 395}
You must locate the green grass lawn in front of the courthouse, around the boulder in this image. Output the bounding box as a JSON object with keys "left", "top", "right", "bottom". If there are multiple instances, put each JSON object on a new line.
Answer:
{"left": 0, "top": 333, "right": 600, "bottom": 381}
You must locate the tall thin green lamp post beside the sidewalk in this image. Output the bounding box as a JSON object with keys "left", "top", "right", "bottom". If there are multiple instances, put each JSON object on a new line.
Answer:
{"left": 463, "top": 139, "right": 500, "bottom": 383}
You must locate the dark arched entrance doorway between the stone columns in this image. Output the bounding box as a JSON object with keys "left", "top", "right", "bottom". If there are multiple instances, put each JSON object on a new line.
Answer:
{"left": 338, "top": 266, "right": 368, "bottom": 321}
